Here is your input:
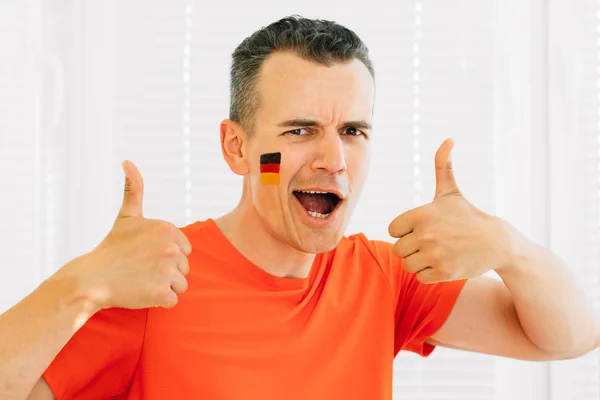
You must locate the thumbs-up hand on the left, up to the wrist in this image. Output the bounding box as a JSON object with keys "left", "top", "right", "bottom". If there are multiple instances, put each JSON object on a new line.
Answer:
{"left": 59, "top": 161, "right": 192, "bottom": 309}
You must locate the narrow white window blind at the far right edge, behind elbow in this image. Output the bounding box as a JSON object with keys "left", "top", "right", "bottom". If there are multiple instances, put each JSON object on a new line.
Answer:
{"left": 548, "top": 0, "right": 600, "bottom": 400}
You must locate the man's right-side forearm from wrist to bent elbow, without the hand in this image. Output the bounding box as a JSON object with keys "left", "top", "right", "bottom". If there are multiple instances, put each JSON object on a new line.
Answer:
{"left": 496, "top": 241, "right": 600, "bottom": 358}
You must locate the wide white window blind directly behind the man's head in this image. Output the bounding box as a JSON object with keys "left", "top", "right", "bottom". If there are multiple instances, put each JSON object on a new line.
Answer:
{"left": 105, "top": 0, "right": 495, "bottom": 400}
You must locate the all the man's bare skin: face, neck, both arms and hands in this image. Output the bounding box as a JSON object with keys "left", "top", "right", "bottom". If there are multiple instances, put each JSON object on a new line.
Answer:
{"left": 0, "top": 53, "right": 600, "bottom": 399}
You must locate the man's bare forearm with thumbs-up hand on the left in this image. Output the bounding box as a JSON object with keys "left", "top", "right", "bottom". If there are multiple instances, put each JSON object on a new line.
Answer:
{"left": 0, "top": 163, "right": 191, "bottom": 399}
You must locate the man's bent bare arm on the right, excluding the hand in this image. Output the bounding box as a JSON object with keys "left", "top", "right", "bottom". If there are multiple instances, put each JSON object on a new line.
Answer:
{"left": 428, "top": 244, "right": 600, "bottom": 361}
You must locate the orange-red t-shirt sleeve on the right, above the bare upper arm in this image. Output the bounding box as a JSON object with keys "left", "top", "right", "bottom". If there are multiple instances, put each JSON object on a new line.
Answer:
{"left": 371, "top": 241, "right": 466, "bottom": 357}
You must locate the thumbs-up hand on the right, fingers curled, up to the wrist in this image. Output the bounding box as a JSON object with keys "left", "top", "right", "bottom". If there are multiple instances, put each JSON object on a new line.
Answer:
{"left": 389, "top": 139, "right": 518, "bottom": 283}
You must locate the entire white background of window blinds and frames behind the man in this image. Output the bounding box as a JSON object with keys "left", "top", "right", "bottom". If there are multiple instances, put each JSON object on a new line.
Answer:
{"left": 0, "top": 0, "right": 600, "bottom": 400}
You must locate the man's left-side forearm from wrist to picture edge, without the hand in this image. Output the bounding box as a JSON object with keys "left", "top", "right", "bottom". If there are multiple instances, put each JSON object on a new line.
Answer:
{"left": 0, "top": 259, "right": 97, "bottom": 398}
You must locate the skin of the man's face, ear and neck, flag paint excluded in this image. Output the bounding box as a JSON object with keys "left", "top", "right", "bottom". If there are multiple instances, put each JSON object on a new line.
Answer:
{"left": 216, "top": 52, "right": 374, "bottom": 277}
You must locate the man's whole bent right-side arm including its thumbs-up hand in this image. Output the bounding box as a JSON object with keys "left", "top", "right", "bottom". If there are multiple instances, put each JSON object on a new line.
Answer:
{"left": 389, "top": 141, "right": 600, "bottom": 360}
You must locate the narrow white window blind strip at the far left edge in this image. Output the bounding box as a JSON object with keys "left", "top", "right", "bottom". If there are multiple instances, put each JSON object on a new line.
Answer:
{"left": 0, "top": 1, "right": 43, "bottom": 311}
